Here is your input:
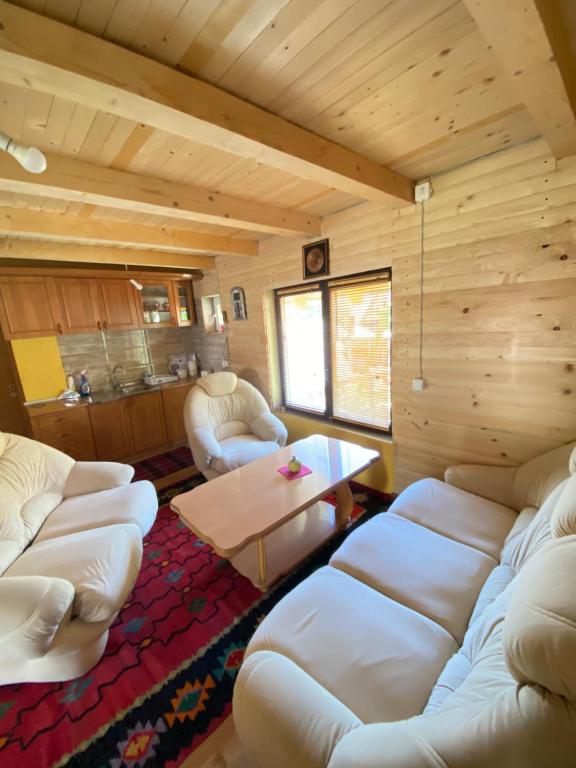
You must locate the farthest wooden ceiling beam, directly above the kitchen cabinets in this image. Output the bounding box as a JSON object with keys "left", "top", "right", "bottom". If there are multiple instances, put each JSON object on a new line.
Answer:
{"left": 0, "top": 238, "right": 214, "bottom": 271}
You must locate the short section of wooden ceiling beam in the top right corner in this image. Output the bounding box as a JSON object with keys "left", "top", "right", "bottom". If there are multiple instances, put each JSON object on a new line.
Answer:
{"left": 464, "top": 0, "right": 576, "bottom": 159}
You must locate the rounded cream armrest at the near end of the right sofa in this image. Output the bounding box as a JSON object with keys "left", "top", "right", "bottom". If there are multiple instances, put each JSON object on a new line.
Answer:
{"left": 233, "top": 651, "right": 362, "bottom": 768}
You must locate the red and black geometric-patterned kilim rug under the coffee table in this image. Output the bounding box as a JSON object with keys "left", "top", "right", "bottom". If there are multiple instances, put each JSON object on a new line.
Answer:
{"left": 0, "top": 480, "right": 389, "bottom": 768}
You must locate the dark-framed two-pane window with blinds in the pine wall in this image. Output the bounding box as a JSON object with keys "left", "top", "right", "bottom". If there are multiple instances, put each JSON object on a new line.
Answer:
{"left": 276, "top": 270, "right": 391, "bottom": 431}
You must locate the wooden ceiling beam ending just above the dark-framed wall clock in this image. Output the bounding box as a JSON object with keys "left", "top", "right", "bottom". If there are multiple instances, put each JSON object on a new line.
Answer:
{"left": 0, "top": 152, "right": 320, "bottom": 237}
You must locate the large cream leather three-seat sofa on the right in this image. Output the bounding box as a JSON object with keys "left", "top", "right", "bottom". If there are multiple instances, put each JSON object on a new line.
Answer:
{"left": 234, "top": 444, "right": 576, "bottom": 768}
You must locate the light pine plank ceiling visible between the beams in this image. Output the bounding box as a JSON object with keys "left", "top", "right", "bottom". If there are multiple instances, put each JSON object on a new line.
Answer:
{"left": 0, "top": 0, "right": 574, "bottom": 268}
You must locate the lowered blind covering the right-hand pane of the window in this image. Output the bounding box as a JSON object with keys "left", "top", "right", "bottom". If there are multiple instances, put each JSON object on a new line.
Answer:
{"left": 328, "top": 274, "right": 391, "bottom": 430}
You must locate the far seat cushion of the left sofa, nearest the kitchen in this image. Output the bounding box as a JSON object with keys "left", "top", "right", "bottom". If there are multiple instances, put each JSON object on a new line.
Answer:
{"left": 34, "top": 480, "right": 158, "bottom": 545}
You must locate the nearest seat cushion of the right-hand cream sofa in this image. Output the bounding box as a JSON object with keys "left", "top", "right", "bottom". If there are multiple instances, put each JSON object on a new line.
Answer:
{"left": 247, "top": 566, "right": 456, "bottom": 723}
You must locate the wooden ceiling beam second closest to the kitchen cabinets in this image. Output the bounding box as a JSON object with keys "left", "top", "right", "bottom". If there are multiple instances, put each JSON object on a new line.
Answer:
{"left": 0, "top": 207, "right": 258, "bottom": 256}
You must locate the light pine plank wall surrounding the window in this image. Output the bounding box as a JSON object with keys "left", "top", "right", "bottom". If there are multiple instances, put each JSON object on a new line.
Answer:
{"left": 217, "top": 141, "right": 576, "bottom": 490}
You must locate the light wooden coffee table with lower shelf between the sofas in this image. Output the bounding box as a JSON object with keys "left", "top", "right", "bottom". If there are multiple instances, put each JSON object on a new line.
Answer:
{"left": 170, "top": 435, "right": 380, "bottom": 590}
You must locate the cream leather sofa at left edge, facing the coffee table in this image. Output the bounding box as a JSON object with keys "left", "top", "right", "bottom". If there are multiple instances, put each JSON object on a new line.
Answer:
{"left": 0, "top": 433, "right": 158, "bottom": 685}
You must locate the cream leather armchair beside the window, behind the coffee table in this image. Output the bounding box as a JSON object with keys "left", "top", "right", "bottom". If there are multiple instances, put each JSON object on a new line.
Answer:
{"left": 184, "top": 371, "right": 288, "bottom": 480}
